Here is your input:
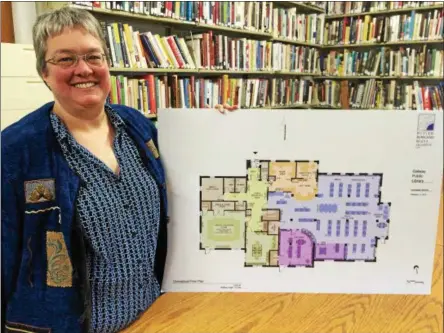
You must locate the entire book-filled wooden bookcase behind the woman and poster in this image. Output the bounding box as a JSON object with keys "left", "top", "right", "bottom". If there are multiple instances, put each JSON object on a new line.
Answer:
{"left": 38, "top": 1, "right": 444, "bottom": 118}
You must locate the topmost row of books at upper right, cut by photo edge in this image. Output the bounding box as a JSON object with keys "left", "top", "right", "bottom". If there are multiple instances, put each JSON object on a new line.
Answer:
{"left": 324, "top": 1, "right": 442, "bottom": 15}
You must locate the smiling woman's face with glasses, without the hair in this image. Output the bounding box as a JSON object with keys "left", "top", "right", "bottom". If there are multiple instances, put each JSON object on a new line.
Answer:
{"left": 42, "top": 29, "right": 111, "bottom": 110}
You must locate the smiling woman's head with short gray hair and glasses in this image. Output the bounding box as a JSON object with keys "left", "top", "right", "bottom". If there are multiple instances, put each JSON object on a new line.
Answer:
{"left": 33, "top": 9, "right": 111, "bottom": 119}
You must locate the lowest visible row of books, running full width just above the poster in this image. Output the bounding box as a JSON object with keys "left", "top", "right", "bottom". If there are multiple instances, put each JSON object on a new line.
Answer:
{"left": 108, "top": 75, "right": 444, "bottom": 112}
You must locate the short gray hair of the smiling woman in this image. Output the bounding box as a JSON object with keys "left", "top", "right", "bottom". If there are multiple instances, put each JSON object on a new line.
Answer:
{"left": 32, "top": 6, "right": 109, "bottom": 76}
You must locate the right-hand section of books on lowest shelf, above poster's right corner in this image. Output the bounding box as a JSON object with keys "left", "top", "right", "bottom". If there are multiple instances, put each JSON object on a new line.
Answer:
{"left": 341, "top": 79, "right": 444, "bottom": 111}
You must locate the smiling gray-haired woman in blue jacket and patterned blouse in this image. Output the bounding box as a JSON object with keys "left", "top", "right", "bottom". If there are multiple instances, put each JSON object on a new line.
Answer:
{"left": 2, "top": 7, "right": 236, "bottom": 333}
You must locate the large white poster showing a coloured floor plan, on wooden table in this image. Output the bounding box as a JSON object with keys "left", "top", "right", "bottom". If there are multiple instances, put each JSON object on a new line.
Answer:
{"left": 158, "top": 110, "right": 443, "bottom": 294}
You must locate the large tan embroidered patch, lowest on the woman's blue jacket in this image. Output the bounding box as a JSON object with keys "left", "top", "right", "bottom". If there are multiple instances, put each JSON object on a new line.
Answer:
{"left": 46, "top": 231, "right": 72, "bottom": 287}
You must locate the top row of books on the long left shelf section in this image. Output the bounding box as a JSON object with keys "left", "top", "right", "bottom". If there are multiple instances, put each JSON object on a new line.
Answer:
{"left": 74, "top": 1, "right": 330, "bottom": 44}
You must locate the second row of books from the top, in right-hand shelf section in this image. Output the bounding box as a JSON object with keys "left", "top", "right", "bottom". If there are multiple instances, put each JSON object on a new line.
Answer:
{"left": 324, "top": 1, "right": 444, "bottom": 48}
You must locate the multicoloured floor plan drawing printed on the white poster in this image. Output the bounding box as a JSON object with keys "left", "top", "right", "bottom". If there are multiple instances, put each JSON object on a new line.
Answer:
{"left": 200, "top": 160, "right": 391, "bottom": 267}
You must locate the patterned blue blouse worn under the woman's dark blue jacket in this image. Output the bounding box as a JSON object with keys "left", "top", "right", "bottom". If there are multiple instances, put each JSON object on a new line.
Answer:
{"left": 51, "top": 107, "right": 160, "bottom": 333}
